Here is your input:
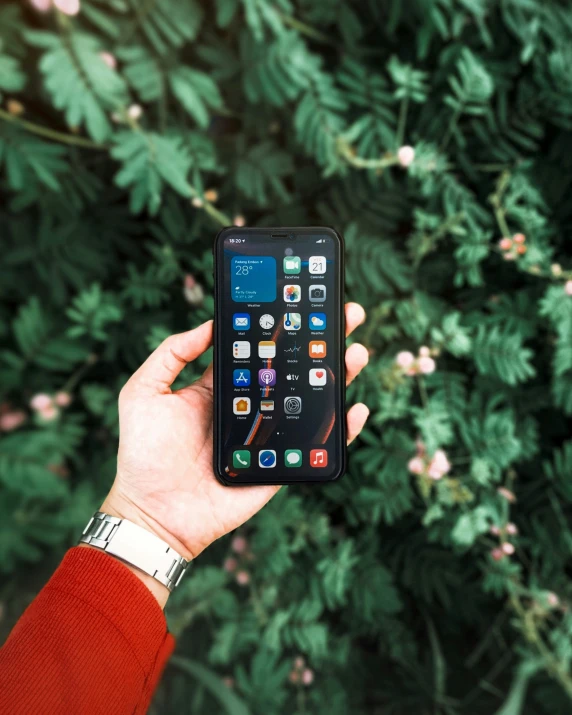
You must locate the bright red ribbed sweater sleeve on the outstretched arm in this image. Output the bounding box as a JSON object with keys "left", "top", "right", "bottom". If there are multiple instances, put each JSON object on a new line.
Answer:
{"left": 0, "top": 547, "right": 174, "bottom": 715}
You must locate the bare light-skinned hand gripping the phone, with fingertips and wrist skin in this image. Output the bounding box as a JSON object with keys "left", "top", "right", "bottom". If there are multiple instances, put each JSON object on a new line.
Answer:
{"left": 101, "top": 303, "right": 369, "bottom": 604}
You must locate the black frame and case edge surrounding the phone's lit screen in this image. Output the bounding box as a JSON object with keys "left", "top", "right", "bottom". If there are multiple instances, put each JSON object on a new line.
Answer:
{"left": 213, "top": 226, "right": 347, "bottom": 487}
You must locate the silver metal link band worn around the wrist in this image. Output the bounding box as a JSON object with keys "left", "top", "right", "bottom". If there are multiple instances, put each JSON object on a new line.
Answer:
{"left": 80, "top": 511, "right": 189, "bottom": 591}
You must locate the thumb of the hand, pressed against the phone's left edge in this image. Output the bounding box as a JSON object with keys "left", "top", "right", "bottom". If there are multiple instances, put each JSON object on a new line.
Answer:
{"left": 127, "top": 320, "right": 213, "bottom": 393}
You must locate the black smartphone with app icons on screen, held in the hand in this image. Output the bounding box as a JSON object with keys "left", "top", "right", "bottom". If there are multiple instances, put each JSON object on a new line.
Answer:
{"left": 214, "top": 226, "right": 346, "bottom": 486}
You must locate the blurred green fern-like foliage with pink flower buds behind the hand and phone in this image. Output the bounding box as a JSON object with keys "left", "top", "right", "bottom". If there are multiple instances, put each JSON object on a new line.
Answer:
{"left": 0, "top": 0, "right": 572, "bottom": 715}
